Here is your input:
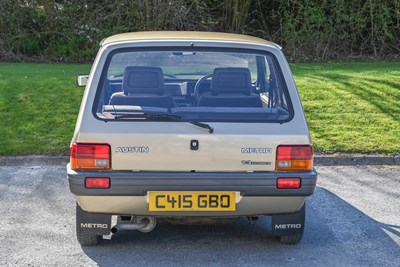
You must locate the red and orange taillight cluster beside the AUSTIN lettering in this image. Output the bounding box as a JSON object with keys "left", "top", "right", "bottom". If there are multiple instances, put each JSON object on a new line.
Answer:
{"left": 71, "top": 143, "right": 111, "bottom": 170}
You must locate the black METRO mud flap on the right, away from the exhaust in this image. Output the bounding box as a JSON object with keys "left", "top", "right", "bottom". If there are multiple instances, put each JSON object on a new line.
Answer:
{"left": 271, "top": 203, "right": 306, "bottom": 236}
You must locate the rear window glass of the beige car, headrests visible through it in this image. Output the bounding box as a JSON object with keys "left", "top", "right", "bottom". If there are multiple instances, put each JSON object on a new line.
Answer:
{"left": 94, "top": 48, "right": 292, "bottom": 122}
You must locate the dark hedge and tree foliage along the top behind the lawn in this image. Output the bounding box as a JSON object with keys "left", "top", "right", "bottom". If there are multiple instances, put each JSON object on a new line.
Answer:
{"left": 0, "top": 0, "right": 400, "bottom": 62}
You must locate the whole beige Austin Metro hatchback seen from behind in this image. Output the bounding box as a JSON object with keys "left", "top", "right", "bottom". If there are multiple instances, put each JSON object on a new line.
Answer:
{"left": 67, "top": 32, "right": 317, "bottom": 245}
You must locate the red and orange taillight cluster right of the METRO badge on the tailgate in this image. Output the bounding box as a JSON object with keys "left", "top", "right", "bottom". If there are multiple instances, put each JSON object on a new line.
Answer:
{"left": 275, "top": 145, "right": 313, "bottom": 171}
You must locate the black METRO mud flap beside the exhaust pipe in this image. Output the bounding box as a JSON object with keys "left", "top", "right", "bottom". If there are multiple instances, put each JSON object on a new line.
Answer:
{"left": 76, "top": 203, "right": 111, "bottom": 235}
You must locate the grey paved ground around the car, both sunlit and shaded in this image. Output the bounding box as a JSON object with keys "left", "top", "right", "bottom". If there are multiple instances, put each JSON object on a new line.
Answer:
{"left": 0, "top": 166, "right": 400, "bottom": 266}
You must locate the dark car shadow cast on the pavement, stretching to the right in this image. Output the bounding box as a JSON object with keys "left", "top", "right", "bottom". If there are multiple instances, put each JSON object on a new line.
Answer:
{"left": 83, "top": 187, "right": 400, "bottom": 266}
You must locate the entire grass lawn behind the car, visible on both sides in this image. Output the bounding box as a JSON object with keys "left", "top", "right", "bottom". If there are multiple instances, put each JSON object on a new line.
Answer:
{"left": 0, "top": 62, "right": 400, "bottom": 155}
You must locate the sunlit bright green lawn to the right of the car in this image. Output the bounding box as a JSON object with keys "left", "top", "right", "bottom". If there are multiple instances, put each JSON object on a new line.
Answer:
{"left": 292, "top": 62, "right": 400, "bottom": 154}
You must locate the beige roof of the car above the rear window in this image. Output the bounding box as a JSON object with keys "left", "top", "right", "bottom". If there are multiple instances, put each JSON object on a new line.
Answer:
{"left": 100, "top": 31, "right": 280, "bottom": 48}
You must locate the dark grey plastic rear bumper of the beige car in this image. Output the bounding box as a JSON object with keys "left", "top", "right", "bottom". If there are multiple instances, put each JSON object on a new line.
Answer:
{"left": 67, "top": 164, "right": 317, "bottom": 197}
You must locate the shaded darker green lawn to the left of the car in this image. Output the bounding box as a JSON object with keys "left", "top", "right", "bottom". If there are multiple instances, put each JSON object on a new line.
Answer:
{"left": 0, "top": 63, "right": 90, "bottom": 155}
